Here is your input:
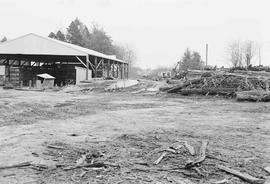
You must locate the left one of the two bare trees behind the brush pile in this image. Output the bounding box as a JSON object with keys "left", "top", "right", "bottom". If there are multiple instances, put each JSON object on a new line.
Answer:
{"left": 228, "top": 40, "right": 243, "bottom": 67}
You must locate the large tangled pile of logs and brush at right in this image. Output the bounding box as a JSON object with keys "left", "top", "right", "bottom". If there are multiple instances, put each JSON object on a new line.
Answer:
{"left": 168, "top": 73, "right": 269, "bottom": 100}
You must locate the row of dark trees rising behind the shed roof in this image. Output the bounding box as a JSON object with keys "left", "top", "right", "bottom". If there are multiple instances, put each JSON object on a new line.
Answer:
{"left": 49, "top": 18, "right": 136, "bottom": 65}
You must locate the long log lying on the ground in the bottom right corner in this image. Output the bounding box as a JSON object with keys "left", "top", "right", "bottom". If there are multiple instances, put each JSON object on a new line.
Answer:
{"left": 217, "top": 165, "right": 265, "bottom": 184}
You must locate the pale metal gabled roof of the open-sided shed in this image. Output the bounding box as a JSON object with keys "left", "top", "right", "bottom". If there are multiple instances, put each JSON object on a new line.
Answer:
{"left": 0, "top": 33, "right": 126, "bottom": 63}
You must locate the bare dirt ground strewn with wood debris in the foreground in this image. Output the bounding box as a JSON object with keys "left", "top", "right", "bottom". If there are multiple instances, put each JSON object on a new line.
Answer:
{"left": 0, "top": 82, "right": 270, "bottom": 184}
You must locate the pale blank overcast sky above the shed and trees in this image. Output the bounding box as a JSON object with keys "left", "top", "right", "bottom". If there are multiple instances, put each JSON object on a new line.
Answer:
{"left": 0, "top": 0, "right": 270, "bottom": 68}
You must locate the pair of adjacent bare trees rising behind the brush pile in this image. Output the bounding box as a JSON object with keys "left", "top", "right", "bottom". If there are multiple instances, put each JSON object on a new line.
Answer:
{"left": 227, "top": 40, "right": 258, "bottom": 67}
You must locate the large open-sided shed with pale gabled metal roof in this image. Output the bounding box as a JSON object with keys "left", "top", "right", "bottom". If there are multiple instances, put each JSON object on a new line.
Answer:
{"left": 0, "top": 33, "right": 128, "bottom": 85}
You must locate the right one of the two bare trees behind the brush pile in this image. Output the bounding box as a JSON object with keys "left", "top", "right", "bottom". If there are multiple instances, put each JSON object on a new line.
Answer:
{"left": 242, "top": 40, "right": 257, "bottom": 67}
